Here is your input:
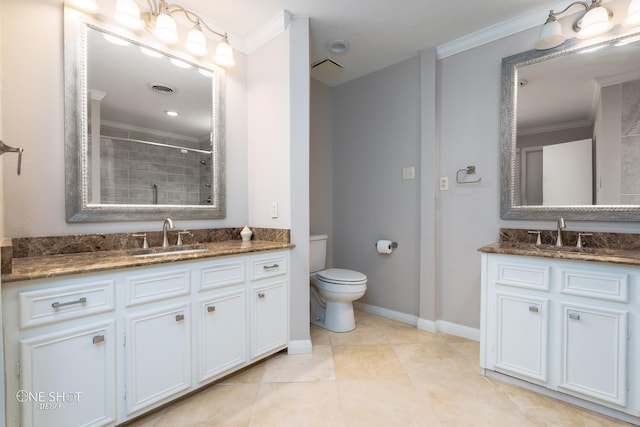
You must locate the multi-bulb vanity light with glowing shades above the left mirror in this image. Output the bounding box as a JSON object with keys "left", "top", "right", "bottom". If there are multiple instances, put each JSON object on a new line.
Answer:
{"left": 67, "top": 0, "right": 235, "bottom": 67}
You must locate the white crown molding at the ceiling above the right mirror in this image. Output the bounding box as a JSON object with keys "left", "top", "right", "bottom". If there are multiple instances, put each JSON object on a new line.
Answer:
{"left": 436, "top": 0, "right": 572, "bottom": 59}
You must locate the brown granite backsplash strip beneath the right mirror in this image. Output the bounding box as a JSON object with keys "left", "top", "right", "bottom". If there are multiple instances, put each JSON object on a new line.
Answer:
{"left": 500, "top": 228, "right": 640, "bottom": 250}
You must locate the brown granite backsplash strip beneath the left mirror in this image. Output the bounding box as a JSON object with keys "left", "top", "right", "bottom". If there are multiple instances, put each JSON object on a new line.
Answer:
{"left": 3, "top": 227, "right": 291, "bottom": 260}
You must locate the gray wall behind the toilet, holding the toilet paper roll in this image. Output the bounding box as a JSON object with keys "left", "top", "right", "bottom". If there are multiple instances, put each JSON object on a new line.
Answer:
{"left": 330, "top": 57, "right": 420, "bottom": 315}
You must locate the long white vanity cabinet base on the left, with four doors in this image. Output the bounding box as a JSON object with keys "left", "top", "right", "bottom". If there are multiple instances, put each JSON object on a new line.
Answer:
{"left": 2, "top": 250, "right": 289, "bottom": 427}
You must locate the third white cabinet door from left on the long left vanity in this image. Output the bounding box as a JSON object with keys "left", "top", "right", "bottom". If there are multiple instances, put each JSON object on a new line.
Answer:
{"left": 197, "top": 289, "right": 247, "bottom": 382}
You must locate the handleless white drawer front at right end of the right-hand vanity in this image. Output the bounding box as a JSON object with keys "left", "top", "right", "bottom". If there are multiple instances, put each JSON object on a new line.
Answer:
{"left": 560, "top": 266, "right": 629, "bottom": 302}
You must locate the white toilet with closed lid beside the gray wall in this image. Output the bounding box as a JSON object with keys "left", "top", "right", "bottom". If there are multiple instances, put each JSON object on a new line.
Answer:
{"left": 309, "top": 234, "right": 367, "bottom": 332}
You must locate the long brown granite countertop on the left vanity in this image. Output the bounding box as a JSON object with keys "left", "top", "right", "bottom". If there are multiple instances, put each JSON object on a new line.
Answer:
{"left": 2, "top": 240, "right": 295, "bottom": 283}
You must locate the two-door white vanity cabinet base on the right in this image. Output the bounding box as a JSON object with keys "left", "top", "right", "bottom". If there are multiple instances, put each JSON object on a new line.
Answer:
{"left": 480, "top": 253, "right": 640, "bottom": 422}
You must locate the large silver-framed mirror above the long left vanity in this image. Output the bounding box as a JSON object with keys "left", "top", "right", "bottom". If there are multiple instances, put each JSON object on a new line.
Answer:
{"left": 64, "top": 8, "right": 225, "bottom": 222}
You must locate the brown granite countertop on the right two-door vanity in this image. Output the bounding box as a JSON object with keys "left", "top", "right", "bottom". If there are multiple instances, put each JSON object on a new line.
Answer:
{"left": 478, "top": 242, "right": 640, "bottom": 266}
